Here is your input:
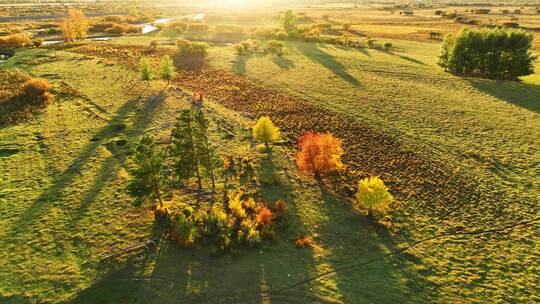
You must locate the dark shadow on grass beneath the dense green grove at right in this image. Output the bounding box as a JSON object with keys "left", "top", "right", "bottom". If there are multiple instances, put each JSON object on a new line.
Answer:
{"left": 467, "top": 78, "right": 540, "bottom": 113}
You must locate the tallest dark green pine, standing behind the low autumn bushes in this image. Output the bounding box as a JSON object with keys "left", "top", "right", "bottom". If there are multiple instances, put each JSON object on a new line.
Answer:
{"left": 170, "top": 109, "right": 216, "bottom": 191}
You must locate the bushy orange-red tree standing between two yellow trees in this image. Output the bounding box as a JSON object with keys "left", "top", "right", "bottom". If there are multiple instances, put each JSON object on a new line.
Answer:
{"left": 296, "top": 132, "right": 343, "bottom": 177}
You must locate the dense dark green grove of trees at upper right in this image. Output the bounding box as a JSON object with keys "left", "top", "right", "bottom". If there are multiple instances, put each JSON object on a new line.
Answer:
{"left": 438, "top": 28, "right": 536, "bottom": 79}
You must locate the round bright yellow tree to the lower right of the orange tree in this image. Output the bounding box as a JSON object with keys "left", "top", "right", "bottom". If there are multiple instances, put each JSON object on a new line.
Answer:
{"left": 356, "top": 177, "right": 394, "bottom": 214}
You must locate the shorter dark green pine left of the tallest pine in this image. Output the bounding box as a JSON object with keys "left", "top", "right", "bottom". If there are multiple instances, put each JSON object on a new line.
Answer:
{"left": 127, "top": 135, "right": 165, "bottom": 207}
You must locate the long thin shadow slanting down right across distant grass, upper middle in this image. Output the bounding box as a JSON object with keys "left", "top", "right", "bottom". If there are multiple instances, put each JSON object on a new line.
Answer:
{"left": 294, "top": 43, "right": 361, "bottom": 87}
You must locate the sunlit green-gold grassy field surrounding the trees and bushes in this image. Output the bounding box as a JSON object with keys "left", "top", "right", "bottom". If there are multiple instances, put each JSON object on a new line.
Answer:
{"left": 0, "top": 2, "right": 540, "bottom": 303}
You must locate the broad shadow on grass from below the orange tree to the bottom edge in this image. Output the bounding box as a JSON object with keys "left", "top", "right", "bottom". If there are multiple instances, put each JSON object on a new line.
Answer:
{"left": 298, "top": 187, "right": 436, "bottom": 303}
